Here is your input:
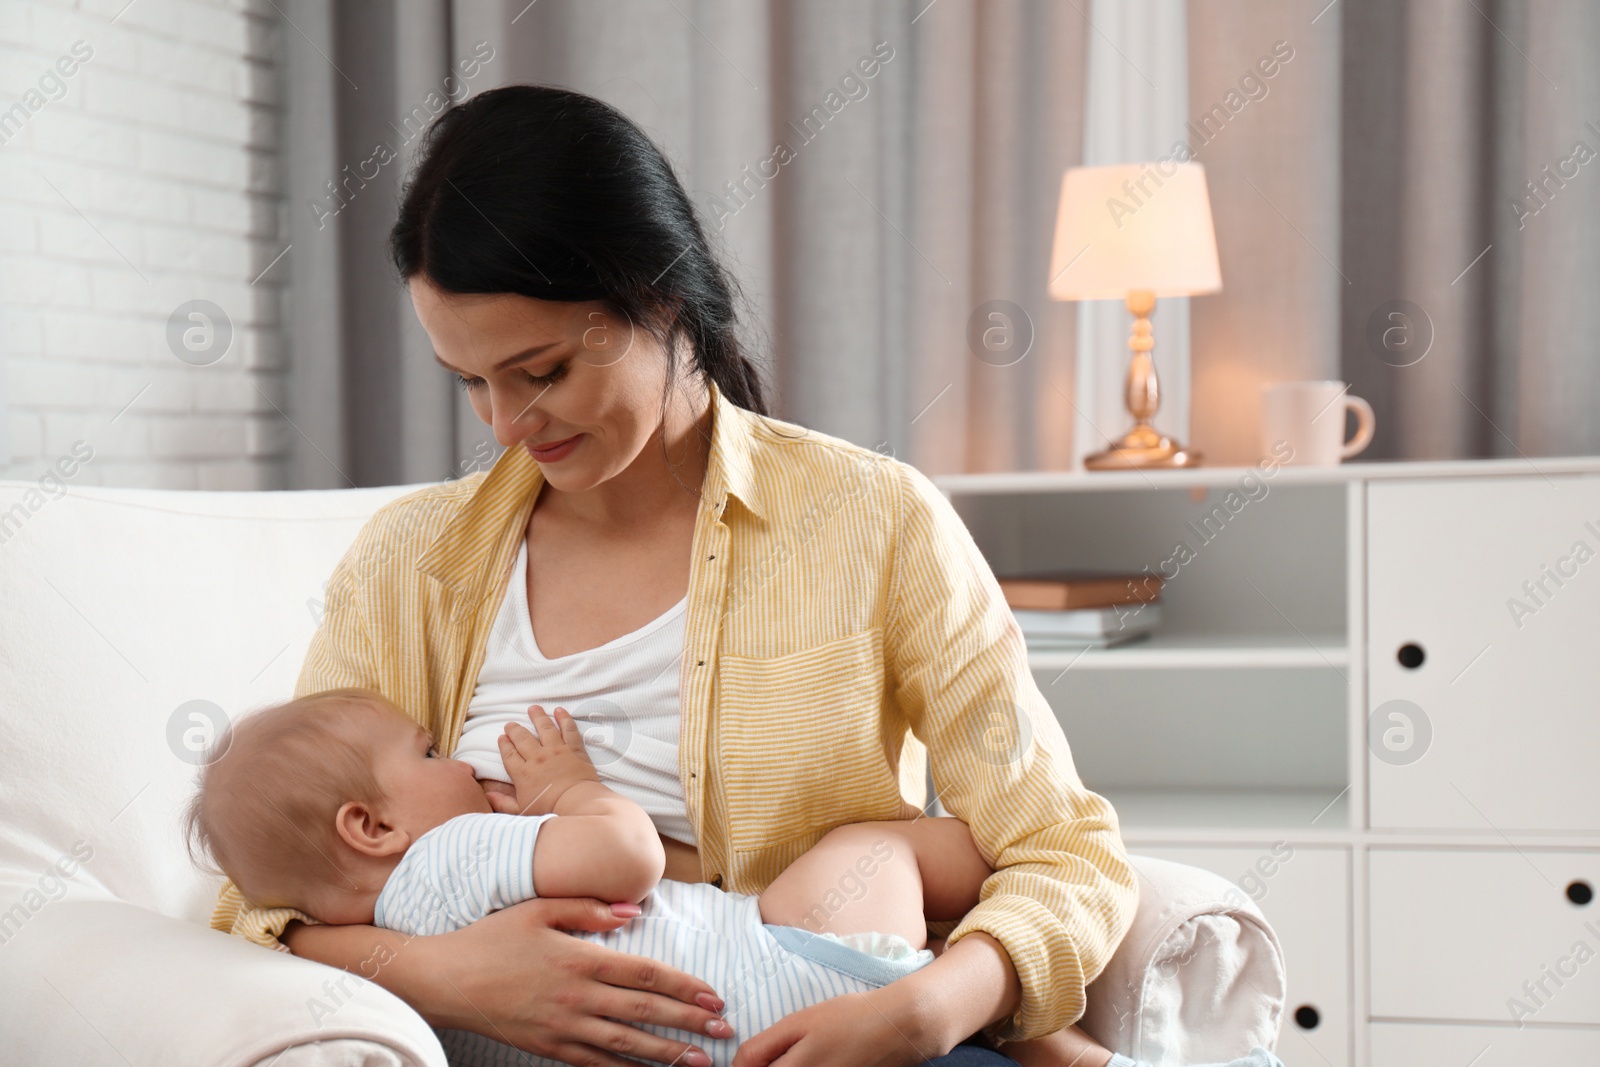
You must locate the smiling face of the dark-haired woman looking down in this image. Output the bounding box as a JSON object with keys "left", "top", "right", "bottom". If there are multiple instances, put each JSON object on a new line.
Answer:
{"left": 408, "top": 275, "right": 667, "bottom": 491}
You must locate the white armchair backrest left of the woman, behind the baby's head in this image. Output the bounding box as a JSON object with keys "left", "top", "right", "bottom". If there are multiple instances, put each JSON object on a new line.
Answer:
{"left": 0, "top": 482, "right": 416, "bottom": 936}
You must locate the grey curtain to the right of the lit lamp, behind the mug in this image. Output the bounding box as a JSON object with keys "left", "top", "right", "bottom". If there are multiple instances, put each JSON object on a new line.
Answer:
{"left": 1186, "top": 0, "right": 1600, "bottom": 462}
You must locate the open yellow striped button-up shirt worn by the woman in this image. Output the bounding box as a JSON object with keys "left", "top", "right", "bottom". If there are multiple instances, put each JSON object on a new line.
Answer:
{"left": 211, "top": 377, "right": 1136, "bottom": 1040}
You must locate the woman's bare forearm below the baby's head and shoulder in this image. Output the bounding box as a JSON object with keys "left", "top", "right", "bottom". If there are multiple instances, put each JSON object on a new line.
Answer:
{"left": 278, "top": 920, "right": 464, "bottom": 1027}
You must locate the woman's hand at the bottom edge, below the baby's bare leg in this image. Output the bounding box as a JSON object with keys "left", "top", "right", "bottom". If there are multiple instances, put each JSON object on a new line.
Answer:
{"left": 733, "top": 979, "right": 955, "bottom": 1067}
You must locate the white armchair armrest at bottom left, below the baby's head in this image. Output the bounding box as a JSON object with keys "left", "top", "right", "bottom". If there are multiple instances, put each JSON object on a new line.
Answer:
{"left": 0, "top": 899, "right": 446, "bottom": 1067}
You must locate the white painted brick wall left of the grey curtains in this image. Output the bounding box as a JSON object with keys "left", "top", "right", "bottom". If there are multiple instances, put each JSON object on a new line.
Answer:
{"left": 0, "top": 0, "right": 284, "bottom": 490}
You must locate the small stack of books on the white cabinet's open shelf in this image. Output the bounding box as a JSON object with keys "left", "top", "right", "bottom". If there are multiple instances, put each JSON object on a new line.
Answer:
{"left": 1000, "top": 573, "right": 1162, "bottom": 653}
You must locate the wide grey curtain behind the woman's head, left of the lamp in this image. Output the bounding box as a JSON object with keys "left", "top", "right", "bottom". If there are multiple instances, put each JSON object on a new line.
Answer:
{"left": 283, "top": 0, "right": 1091, "bottom": 486}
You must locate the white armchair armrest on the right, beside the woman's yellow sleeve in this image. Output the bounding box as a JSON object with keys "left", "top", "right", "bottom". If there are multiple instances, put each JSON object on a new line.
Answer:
{"left": 1078, "top": 856, "right": 1286, "bottom": 1067}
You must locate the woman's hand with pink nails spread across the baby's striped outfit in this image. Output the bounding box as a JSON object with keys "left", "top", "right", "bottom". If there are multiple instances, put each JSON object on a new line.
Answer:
{"left": 422, "top": 897, "right": 733, "bottom": 1067}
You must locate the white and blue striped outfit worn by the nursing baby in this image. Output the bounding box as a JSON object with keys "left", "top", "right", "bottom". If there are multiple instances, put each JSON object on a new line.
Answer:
{"left": 373, "top": 813, "right": 933, "bottom": 1067}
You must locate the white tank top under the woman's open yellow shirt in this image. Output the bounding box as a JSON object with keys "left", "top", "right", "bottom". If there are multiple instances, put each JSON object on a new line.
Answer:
{"left": 454, "top": 541, "right": 696, "bottom": 845}
